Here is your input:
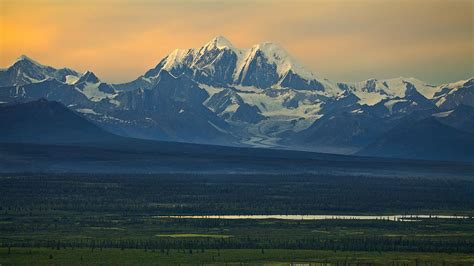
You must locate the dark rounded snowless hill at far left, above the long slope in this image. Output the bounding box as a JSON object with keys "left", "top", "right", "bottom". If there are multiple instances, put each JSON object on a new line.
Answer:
{"left": 0, "top": 100, "right": 119, "bottom": 143}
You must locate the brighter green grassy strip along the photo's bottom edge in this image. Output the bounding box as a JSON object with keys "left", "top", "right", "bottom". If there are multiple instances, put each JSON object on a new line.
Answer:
{"left": 0, "top": 248, "right": 474, "bottom": 265}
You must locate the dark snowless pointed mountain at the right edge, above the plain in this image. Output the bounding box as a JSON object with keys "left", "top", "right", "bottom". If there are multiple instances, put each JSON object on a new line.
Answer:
{"left": 357, "top": 117, "right": 474, "bottom": 161}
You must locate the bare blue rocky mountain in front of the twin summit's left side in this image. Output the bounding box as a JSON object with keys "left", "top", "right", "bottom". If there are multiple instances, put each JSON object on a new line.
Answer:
{"left": 113, "top": 70, "right": 232, "bottom": 144}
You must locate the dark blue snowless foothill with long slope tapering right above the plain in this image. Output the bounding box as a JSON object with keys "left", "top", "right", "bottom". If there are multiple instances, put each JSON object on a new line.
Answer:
{"left": 0, "top": 99, "right": 474, "bottom": 175}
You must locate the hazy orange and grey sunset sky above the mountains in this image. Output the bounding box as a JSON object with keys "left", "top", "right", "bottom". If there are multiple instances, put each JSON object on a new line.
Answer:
{"left": 0, "top": 0, "right": 474, "bottom": 85}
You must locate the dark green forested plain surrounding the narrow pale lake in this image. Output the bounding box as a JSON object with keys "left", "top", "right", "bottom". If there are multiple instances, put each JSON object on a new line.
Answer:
{"left": 0, "top": 172, "right": 474, "bottom": 265}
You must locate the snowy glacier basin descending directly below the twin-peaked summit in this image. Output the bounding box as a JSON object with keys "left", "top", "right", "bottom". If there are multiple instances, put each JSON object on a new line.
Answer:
{"left": 200, "top": 84, "right": 329, "bottom": 147}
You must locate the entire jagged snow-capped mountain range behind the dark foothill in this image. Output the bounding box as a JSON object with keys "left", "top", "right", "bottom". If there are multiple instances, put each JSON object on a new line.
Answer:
{"left": 0, "top": 36, "right": 474, "bottom": 160}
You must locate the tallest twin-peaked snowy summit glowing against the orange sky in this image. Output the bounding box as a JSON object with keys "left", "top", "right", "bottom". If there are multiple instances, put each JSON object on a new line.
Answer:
{"left": 122, "top": 36, "right": 340, "bottom": 91}
